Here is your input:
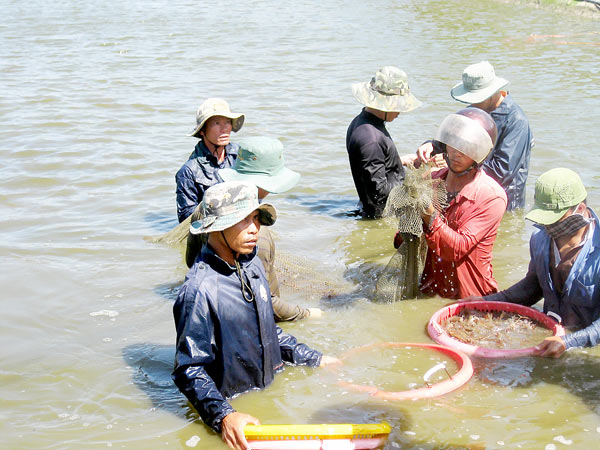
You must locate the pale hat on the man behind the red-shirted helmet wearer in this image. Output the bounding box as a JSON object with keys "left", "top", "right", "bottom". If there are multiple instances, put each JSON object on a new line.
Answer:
{"left": 450, "top": 61, "right": 508, "bottom": 104}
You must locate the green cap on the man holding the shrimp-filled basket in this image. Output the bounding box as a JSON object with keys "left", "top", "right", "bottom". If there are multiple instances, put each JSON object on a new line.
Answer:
{"left": 525, "top": 168, "right": 587, "bottom": 225}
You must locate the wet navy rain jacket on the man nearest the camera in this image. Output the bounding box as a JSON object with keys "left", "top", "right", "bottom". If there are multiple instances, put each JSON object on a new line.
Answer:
{"left": 173, "top": 245, "right": 322, "bottom": 432}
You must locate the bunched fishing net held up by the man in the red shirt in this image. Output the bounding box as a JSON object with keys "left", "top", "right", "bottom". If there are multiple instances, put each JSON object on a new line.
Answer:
{"left": 375, "top": 164, "right": 448, "bottom": 303}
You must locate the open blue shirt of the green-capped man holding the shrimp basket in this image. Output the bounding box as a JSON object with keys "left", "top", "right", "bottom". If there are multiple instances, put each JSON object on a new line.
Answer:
{"left": 485, "top": 208, "right": 600, "bottom": 348}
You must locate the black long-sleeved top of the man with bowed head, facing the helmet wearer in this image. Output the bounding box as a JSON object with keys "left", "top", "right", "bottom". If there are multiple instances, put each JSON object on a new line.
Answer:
{"left": 346, "top": 108, "right": 404, "bottom": 218}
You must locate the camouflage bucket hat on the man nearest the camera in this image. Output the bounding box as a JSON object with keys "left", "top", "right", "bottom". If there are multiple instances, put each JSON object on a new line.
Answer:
{"left": 190, "top": 181, "right": 277, "bottom": 234}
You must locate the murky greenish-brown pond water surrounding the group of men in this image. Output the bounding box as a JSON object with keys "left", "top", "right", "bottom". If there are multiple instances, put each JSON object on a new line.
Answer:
{"left": 0, "top": 0, "right": 600, "bottom": 449}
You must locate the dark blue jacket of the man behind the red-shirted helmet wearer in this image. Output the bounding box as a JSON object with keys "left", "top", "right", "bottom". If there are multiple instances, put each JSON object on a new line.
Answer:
{"left": 483, "top": 94, "right": 533, "bottom": 211}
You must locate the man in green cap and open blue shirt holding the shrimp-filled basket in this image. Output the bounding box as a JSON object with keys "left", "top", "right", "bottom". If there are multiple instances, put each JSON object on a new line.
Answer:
{"left": 466, "top": 168, "right": 600, "bottom": 358}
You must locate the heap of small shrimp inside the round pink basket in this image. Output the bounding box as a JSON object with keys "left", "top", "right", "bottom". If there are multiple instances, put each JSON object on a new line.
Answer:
{"left": 442, "top": 309, "right": 552, "bottom": 350}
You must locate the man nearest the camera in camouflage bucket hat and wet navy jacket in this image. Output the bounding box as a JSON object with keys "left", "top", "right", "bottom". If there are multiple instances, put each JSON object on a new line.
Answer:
{"left": 172, "top": 181, "right": 339, "bottom": 449}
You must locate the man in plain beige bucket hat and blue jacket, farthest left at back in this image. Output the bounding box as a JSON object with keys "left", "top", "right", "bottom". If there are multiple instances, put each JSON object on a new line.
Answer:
{"left": 175, "top": 98, "right": 245, "bottom": 222}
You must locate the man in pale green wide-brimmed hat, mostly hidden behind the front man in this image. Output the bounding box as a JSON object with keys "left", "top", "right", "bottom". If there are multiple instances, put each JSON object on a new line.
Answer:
{"left": 185, "top": 136, "right": 322, "bottom": 321}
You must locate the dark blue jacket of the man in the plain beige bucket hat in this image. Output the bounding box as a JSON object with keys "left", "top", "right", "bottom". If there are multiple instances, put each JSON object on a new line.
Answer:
{"left": 175, "top": 140, "right": 239, "bottom": 223}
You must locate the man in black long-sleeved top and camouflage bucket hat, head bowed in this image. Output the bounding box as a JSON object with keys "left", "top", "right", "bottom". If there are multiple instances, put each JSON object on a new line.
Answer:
{"left": 346, "top": 66, "right": 421, "bottom": 218}
